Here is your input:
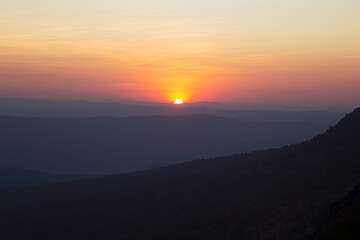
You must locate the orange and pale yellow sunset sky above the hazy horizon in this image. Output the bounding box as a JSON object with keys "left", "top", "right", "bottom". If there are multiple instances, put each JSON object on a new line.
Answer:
{"left": 0, "top": 0, "right": 360, "bottom": 105}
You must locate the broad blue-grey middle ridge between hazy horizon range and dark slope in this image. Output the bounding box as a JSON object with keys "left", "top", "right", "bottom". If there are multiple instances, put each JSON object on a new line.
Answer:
{"left": 0, "top": 115, "right": 328, "bottom": 174}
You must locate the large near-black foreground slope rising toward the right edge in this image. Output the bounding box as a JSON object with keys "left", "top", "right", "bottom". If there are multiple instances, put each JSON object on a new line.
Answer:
{"left": 0, "top": 109, "right": 360, "bottom": 240}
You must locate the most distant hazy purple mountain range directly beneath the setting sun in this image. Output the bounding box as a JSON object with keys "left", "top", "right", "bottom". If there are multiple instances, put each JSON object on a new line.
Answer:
{"left": 0, "top": 99, "right": 344, "bottom": 126}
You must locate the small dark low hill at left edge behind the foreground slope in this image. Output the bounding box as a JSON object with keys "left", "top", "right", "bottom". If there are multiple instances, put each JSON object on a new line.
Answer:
{"left": 0, "top": 168, "right": 92, "bottom": 187}
